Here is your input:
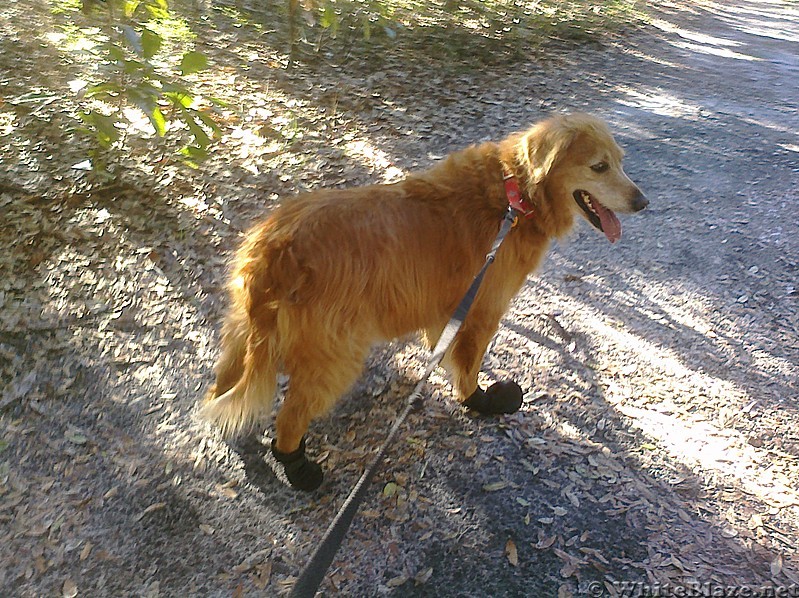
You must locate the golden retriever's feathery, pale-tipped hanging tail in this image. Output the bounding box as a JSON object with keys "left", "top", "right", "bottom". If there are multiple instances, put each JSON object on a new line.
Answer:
{"left": 200, "top": 280, "right": 279, "bottom": 436}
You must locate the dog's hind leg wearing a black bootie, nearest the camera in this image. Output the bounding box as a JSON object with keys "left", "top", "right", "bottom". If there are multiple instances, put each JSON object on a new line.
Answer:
{"left": 272, "top": 349, "right": 366, "bottom": 491}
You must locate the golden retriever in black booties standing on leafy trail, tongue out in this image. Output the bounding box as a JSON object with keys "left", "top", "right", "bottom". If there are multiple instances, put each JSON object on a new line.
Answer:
{"left": 201, "top": 114, "right": 648, "bottom": 490}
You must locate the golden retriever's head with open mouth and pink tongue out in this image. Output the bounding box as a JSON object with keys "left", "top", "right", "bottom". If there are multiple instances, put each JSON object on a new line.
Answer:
{"left": 519, "top": 114, "right": 649, "bottom": 243}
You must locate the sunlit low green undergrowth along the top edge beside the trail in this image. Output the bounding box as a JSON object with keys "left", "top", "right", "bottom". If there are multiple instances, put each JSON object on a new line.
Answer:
{"left": 290, "top": 0, "right": 643, "bottom": 61}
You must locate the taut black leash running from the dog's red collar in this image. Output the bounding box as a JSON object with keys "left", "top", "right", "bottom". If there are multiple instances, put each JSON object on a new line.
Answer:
{"left": 291, "top": 207, "right": 519, "bottom": 598}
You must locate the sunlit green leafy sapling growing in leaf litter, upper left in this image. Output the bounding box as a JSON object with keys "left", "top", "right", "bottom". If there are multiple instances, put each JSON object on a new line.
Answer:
{"left": 80, "top": 0, "right": 219, "bottom": 170}
